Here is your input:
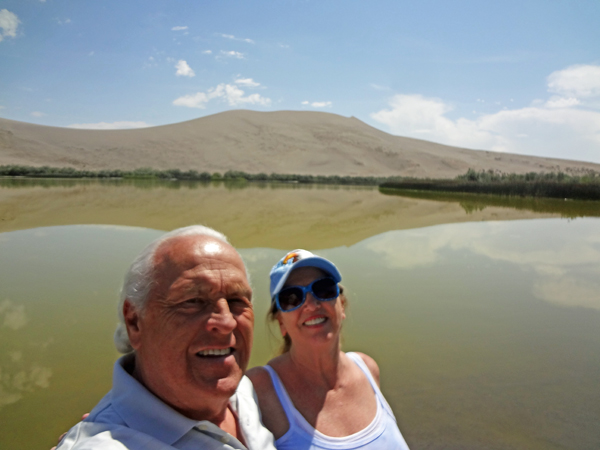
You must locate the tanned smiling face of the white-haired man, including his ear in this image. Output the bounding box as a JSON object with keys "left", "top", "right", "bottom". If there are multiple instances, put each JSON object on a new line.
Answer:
{"left": 124, "top": 236, "right": 254, "bottom": 418}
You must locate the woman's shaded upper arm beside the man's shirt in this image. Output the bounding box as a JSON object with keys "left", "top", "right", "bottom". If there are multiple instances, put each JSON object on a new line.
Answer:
{"left": 246, "top": 367, "right": 290, "bottom": 439}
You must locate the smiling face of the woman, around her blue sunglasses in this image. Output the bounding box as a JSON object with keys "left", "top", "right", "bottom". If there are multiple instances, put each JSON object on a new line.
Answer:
{"left": 277, "top": 267, "right": 346, "bottom": 347}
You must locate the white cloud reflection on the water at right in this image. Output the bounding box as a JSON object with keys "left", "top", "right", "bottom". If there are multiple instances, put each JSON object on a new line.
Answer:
{"left": 359, "top": 220, "right": 600, "bottom": 310}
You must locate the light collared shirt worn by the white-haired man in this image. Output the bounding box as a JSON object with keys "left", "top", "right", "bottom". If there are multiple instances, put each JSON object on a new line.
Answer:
{"left": 57, "top": 355, "right": 275, "bottom": 450}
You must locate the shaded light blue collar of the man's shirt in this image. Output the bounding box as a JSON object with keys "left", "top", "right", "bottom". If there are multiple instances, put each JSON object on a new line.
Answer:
{"left": 111, "top": 354, "right": 208, "bottom": 444}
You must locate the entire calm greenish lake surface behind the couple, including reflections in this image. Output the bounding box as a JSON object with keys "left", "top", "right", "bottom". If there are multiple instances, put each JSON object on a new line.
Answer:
{"left": 0, "top": 180, "right": 600, "bottom": 450}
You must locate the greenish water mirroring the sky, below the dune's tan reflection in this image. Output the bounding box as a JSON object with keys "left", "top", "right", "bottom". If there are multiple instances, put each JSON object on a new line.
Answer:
{"left": 0, "top": 222, "right": 600, "bottom": 449}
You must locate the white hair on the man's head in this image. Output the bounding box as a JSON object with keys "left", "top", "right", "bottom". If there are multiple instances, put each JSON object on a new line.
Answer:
{"left": 114, "top": 225, "right": 239, "bottom": 353}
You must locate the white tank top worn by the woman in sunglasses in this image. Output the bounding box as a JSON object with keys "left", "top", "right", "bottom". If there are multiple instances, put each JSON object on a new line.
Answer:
{"left": 264, "top": 353, "right": 408, "bottom": 450}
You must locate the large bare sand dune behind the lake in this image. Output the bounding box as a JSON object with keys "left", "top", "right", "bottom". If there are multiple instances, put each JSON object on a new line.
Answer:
{"left": 0, "top": 110, "right": 600, "bottom": 177}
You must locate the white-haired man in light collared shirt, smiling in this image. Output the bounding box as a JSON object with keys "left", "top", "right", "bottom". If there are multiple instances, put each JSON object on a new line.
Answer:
{"left": 58, "top": 226, "right": 275, "bottom": 450}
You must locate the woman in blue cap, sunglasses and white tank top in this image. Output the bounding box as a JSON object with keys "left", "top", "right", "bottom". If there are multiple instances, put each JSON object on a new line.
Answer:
{"left": 247, "top": 250, "right": 408, "bottom": 450}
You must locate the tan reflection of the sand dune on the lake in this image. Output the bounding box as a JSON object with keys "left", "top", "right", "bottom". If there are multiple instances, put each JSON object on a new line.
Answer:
{"left": 0, "top": 183, "right": 558, "bottom": 249}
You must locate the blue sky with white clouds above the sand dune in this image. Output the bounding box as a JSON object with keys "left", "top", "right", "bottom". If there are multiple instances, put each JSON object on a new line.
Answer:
{"left": 0, "top": 0, "right": 600, "bottom": 163}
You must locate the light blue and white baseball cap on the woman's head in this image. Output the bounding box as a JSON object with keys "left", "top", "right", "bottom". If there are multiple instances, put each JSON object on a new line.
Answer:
{"left": 269, "top": 249, "right": 342, "bottom": 301}
